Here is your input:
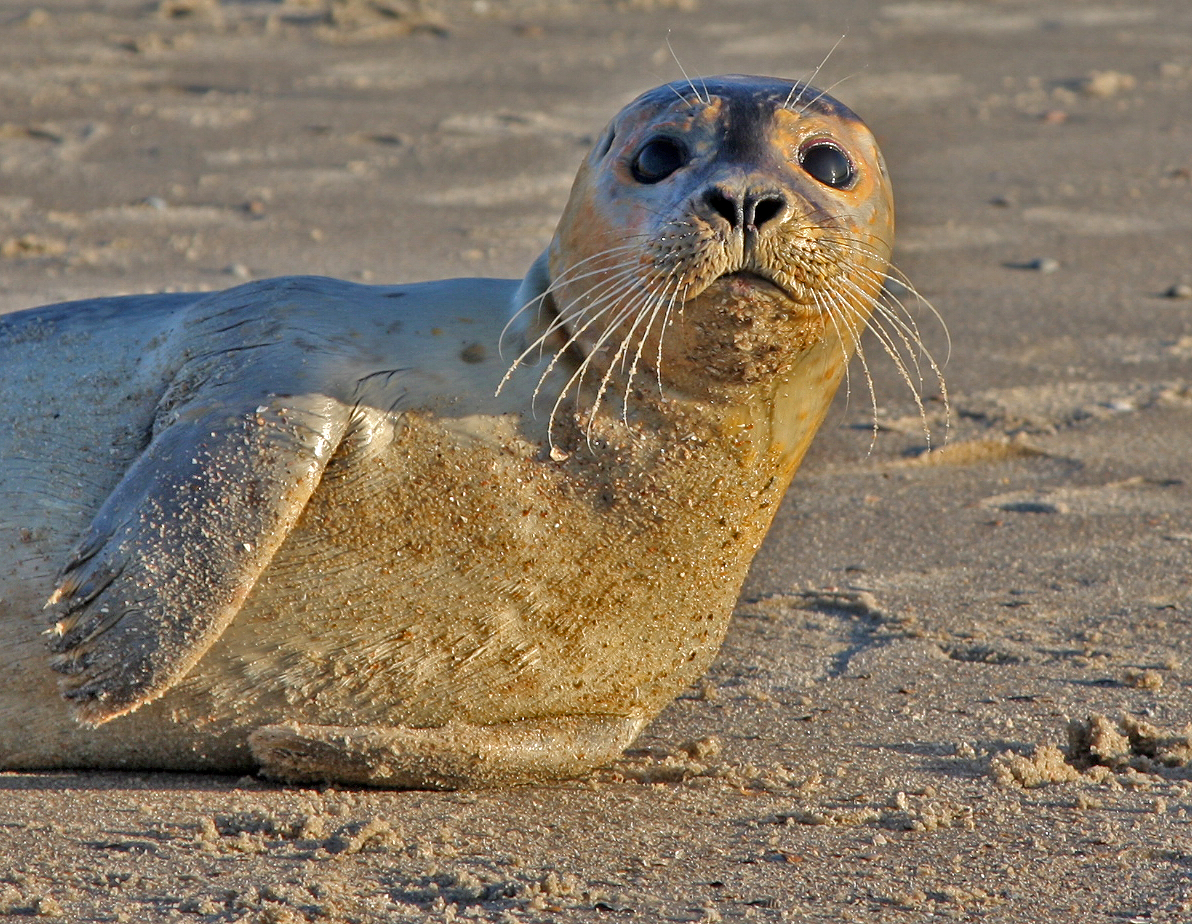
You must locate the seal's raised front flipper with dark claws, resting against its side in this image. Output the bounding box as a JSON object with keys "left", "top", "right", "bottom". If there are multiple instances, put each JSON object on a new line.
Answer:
{"left": 46, "top": 395, "right": 349, "bottom": 725}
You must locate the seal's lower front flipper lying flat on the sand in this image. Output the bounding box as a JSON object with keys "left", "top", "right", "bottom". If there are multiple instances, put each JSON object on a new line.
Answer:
{"left": 248, "top": 715, "right": 647, "bottom": 789}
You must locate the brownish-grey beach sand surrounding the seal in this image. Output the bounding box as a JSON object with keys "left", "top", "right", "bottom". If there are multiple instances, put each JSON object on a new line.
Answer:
{"left": 0, "top": 0, "right": 1192, "bottom": 924}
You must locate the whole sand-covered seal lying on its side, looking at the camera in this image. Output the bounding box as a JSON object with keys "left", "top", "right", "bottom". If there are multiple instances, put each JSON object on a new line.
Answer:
{"left": 0, "top": 75, "right": 893, "bottom": 788}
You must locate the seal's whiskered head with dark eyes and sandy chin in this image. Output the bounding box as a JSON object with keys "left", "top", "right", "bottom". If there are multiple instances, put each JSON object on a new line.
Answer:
{"left": 512, "top": 75, "right": 894, "bottom": 426}
